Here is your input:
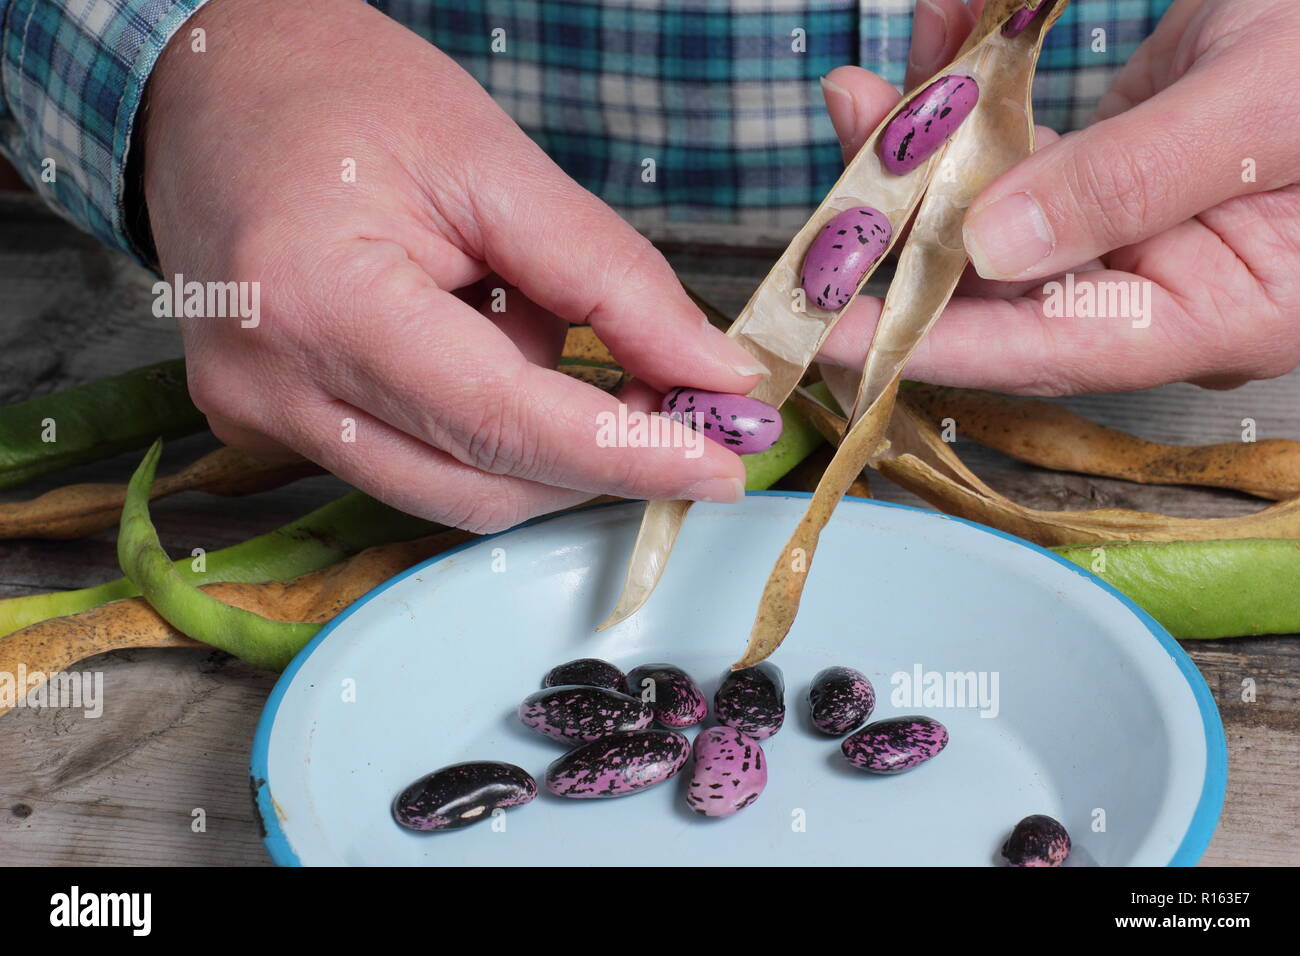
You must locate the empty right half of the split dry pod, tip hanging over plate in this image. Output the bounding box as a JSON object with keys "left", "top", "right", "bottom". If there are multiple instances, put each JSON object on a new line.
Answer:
{"left": 732, "top": 0, "right": 1066, "bottom": 670}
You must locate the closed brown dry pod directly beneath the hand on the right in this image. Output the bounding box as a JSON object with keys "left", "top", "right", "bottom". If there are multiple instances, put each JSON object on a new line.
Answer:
{"left": 906, "top": 384, "right": 1300, "bottom": 501}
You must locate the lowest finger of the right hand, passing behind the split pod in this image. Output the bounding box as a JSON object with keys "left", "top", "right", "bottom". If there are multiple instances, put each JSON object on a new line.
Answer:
{"left": 822, "top": 271, "right": 1225, "bottom": 395}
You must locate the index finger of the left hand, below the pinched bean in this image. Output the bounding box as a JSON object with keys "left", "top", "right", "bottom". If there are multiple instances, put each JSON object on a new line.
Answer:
{"left": 317, "top": 243, "right": 745, "bottom": 501}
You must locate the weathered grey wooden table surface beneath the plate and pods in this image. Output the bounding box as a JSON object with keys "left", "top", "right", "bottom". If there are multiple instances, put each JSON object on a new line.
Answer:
{"left": 0, "top": 194, "right": 1300, "bottom": 865}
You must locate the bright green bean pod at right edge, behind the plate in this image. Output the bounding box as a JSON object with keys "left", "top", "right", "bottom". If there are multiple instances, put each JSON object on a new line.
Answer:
{"left": 1052, "top": 538, "right": 1300, "bottom": 640}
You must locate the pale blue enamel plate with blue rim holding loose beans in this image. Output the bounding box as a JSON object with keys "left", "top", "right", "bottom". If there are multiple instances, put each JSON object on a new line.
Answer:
{"left": 252, "top": 494, "right": 1227, "bottom": 866}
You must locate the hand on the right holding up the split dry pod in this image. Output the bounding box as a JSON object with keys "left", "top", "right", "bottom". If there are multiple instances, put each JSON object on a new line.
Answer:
{"left": 823, "top": 0, "right": 1300, "bottom": 395}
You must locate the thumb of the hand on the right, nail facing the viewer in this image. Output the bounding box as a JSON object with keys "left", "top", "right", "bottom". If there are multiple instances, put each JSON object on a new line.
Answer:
{"left": 963, "top": 55, "right": 1300, "bottom": 280}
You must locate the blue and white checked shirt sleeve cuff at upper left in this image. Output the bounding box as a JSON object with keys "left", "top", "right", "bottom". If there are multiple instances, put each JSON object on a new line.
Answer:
{"left": 0, "top": 0, "right": 207, "bottom": 261}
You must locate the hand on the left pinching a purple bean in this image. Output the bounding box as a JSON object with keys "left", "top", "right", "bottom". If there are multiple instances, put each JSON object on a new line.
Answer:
{"left": 144, "top": 0, "right": 762, "bottom": 532}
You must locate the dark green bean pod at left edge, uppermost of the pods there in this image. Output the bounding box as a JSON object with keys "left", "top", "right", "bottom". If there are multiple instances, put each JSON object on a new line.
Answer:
{"left": 0, "top": 359, "right": 207, "bottom": 488}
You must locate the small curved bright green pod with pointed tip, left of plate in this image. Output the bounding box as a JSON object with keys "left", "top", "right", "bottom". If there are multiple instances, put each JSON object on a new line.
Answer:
{"left": 117, "top": 440, "right": 321, "bottom": 670}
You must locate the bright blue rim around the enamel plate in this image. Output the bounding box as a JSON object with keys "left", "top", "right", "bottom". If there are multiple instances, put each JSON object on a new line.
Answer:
{"left": 248, "top": 492, "right": 1227, "bottom": 866}
